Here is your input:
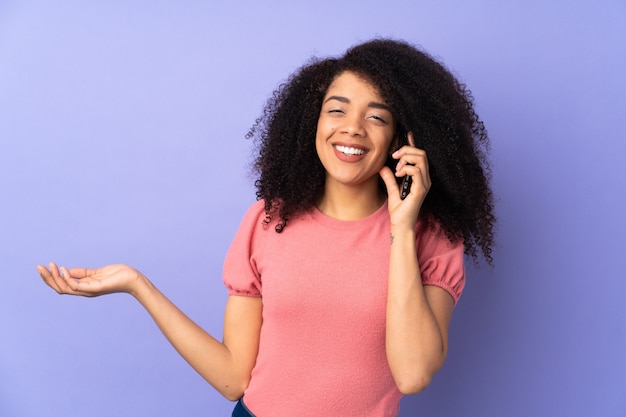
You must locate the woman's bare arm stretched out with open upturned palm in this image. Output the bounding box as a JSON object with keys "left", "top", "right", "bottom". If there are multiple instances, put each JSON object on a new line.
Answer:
{"left": 37, "top": 263, "right": 262, "bottom": 401}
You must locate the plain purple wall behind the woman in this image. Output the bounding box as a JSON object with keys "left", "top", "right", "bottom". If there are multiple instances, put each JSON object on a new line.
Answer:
{"left": 0, "top": 0, "right": 626, "bottom": 417}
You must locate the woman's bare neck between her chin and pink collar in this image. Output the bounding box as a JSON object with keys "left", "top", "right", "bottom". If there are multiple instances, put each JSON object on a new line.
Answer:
{"left": 317, "top": 178, "right": 387, "bottom": 220}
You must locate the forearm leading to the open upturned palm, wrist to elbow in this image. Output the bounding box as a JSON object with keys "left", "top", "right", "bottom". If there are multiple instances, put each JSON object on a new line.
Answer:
{"left": 131, "top": 278, "right": 249, "bottom": 400}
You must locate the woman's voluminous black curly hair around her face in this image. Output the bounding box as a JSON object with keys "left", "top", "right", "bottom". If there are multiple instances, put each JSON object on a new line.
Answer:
{"left": 247, "top": 39, "right": 495, "bottom": 264}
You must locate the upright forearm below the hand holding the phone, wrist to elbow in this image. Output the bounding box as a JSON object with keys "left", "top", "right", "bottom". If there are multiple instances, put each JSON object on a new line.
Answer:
{"left": 386, "top": 228, "right": 447, "bottom": 393}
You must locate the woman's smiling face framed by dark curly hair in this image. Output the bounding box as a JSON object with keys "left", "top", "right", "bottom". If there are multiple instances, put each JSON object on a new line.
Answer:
{"left": 315, "top": 72, "right": 395, "bottom": 193}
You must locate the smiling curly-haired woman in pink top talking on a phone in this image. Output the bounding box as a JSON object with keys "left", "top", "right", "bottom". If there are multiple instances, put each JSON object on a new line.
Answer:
{"left": 38, "top": 39, "right": 495, "bottom": 417}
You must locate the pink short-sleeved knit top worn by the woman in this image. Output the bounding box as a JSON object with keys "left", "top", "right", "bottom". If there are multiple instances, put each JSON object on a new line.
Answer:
{"left": 223, "top": 201, "right": 465, "bottom": 417}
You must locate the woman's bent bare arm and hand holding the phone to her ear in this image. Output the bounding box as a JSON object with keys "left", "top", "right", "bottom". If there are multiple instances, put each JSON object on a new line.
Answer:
{"left": 380, "top": 133, "right": 454, "bottom": 394}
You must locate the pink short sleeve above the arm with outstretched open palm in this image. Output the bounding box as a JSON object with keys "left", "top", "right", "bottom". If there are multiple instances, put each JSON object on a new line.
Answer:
{"left": 222, "top": 201, "right": 265, "bottom": 297}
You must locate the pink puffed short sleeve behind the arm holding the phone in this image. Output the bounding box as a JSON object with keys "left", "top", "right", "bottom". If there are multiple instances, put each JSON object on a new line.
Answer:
{"left": 416, "top": 219, "right": 465, "bottom": 305}
